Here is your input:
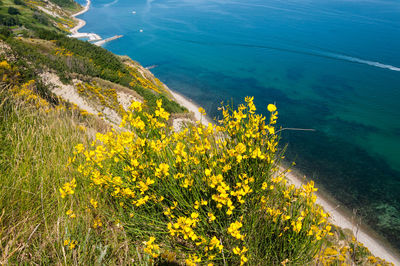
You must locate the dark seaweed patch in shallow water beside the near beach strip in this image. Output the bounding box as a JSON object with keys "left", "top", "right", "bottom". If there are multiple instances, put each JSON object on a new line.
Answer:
{"left": 282, "top": 129, "right": 400, "bottom": 248}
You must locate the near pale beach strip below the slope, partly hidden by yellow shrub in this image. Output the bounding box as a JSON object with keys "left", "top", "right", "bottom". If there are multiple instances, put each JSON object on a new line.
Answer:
{"left": 165, "top": 85, "right": 400, "bottom": 266}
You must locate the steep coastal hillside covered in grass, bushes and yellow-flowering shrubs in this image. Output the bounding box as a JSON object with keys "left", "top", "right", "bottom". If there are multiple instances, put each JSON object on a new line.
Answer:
{"left": 0, "top": 0, "right": 394, "bottom": 265}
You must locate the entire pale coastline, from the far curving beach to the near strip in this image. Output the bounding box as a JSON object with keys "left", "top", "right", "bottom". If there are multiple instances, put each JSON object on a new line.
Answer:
{"left": 70, "top": 0, "right": 400, "bottom": 265}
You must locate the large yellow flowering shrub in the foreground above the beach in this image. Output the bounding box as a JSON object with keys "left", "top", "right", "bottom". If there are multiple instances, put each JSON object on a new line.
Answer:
{"left": 68, "top": 97, "right": 331, "bottom": 265}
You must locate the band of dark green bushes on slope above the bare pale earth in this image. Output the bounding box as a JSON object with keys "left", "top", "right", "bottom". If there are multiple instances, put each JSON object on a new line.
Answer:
{"left": 2, "top": 29, "right": 186, "bottom": 113}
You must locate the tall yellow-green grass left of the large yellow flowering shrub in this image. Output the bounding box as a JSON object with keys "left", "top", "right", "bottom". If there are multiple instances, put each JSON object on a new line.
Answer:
{"left": 0, "top": 84, "right": 152, "bottom": 265}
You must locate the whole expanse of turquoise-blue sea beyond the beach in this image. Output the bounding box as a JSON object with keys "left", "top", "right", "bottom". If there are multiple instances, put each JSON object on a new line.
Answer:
{"left": 76, "top": 0, "right": 400, "bottom": 249}
